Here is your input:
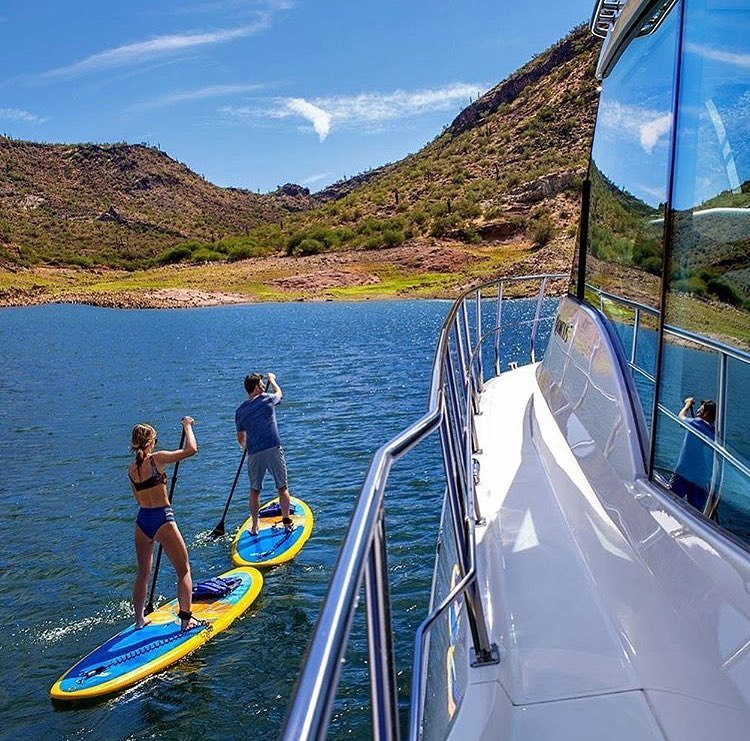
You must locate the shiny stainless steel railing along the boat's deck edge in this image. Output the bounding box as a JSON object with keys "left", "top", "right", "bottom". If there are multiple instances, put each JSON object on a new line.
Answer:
{"left": 282, "top": 274, "right": 568, "bottom": 741}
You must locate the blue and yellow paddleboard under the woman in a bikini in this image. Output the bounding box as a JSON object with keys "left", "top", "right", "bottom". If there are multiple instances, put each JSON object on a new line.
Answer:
{"left": 50, "top": 568, "right": 263, "bottom": 700}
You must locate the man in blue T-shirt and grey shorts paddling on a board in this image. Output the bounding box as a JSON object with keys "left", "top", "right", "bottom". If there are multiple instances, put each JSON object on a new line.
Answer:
{"left": 234, "top": 373, "right": 292, "bottom": 535}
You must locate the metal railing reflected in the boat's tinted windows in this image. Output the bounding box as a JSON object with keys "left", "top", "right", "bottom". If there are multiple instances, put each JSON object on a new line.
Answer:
{"left": 586, "top": 284, "right": 750, "bottom": 517}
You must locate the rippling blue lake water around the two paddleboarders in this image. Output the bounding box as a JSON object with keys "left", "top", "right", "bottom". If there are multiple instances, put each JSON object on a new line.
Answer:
{"left": 0, "top": 301, "right": 449, "bottom": 741}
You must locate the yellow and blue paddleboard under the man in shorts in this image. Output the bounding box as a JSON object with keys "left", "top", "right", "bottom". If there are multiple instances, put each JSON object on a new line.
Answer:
{"left": 232, "top": 497, "right": 313, "bottom": 566}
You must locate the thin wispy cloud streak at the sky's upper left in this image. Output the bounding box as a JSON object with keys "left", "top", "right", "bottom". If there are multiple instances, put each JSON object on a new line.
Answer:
{"left": 42, "top": 22, "right": 269, "bottom": 78}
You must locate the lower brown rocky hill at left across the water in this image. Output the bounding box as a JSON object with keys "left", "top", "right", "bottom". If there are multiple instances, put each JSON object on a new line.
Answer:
{"left": 0, "top": 137, "right": 316, "bottom": 266}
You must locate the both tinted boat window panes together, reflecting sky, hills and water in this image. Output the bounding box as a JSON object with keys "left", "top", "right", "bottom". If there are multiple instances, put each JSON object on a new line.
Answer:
{"left": 579, "top": 0, "right": 750, "bottom": 543}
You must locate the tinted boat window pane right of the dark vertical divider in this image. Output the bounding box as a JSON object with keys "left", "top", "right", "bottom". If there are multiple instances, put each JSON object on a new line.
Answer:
{"left": 655, "top": 0, "right": 750, "bottom": 540}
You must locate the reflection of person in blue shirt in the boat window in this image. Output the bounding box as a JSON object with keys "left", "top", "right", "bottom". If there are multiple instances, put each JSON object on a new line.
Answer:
{"left": 669, "top": 396, "right": 716, "bottom": 511}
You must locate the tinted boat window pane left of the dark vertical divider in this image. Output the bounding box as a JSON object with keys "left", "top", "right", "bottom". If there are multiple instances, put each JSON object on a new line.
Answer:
{"left": 586, "top": 6, "right": 680, "bottom": 425}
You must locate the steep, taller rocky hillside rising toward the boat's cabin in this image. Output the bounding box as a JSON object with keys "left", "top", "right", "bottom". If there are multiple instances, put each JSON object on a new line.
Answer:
{"left": 278, "top": 27, "right": 599, "bottom": 278}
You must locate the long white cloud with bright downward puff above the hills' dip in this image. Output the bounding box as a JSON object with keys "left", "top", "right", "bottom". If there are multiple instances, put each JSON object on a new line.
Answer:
{"left": 221, "top": 82, "right": 489, "bottom": 141}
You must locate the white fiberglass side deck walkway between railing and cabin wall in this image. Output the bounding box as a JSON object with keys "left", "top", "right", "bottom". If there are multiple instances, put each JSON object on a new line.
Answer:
{"left": 477, "top": 366, "right": 637, "bottom": 704}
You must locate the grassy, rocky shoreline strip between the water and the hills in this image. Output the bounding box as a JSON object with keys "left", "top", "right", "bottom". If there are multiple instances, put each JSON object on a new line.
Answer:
{"left": 0, "top": 240, "right": 570, "bottom": 309}
